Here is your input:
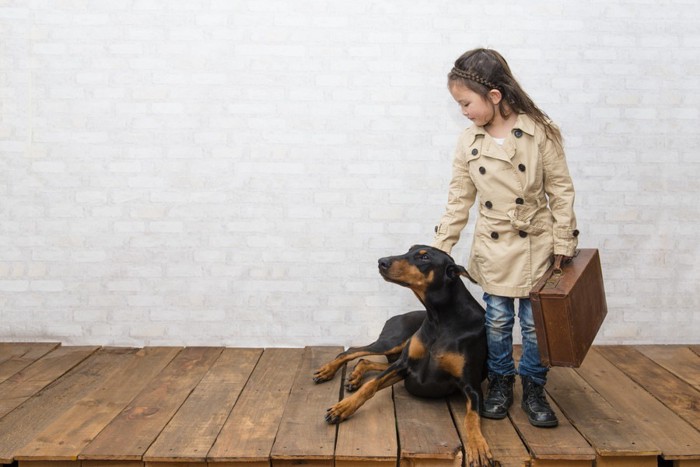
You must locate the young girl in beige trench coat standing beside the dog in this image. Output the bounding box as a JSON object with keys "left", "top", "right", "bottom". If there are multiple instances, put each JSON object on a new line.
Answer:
{"left": 433, "top": 49, "right": 578, "bottom": 427}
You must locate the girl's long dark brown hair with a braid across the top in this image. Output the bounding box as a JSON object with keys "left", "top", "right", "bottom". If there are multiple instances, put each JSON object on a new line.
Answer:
{"left": 447, "top": 49, "right": 562, "bottom": 148}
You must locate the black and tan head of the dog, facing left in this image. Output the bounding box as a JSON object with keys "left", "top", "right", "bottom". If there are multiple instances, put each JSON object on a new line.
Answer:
{"left": 379, "top": 245, "right": 467, "bottom": 301}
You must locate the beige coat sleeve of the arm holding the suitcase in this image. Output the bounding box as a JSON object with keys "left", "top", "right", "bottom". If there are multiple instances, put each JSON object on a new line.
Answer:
{"left": 542, "top": 130, "right": 578, "bottom": 256}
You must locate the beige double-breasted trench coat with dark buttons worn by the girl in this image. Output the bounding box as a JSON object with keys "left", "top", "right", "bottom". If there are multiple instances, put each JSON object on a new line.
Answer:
{"left": 433, "top": 114, "right": 578, "bottom": 297}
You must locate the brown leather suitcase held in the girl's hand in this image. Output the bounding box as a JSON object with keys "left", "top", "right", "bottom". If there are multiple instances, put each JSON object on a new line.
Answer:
{"left": 530, "top": 249, "right": 608, "bottom": 367}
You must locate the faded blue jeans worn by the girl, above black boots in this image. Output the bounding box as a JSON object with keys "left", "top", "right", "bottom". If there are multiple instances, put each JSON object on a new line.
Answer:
{"left": 484, "top": 293, "right": 548, "bottom": 385}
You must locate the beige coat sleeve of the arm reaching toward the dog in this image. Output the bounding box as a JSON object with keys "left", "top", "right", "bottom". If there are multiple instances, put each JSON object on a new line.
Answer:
{"left": 433, "top": 144, "right": 476, "bottom": 254}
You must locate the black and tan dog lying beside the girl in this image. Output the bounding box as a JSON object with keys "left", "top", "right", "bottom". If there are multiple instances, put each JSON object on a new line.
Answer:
{"left": 314, "top": 245, "right": 494, "bottom": 466}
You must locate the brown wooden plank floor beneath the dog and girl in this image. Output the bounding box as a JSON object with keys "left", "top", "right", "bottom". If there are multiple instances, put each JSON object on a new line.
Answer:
{"left": 0, "top": 343, "right": 700, "bottom": 467}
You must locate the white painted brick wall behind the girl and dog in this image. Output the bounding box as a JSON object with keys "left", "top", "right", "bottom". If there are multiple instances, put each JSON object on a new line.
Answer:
{"left": 0, "top": 0, "right": 700, "bottom": 346}
